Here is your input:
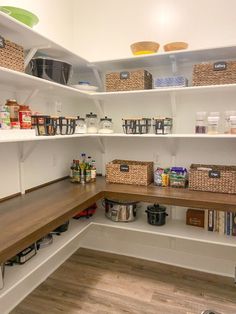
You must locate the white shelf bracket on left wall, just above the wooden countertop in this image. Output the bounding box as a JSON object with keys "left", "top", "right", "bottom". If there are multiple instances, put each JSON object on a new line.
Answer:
{"left": 19, "top": 142, "right": 38, "bottom": 194}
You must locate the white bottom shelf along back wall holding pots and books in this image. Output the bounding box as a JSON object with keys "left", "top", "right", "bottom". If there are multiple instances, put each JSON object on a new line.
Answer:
{"left": 92, "top": 208, "right": 236, "bottom": 247}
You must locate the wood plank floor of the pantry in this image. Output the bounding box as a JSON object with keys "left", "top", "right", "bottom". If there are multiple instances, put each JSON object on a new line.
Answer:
{"left": 11, "top": 249, "right": 236, "bottom": 314}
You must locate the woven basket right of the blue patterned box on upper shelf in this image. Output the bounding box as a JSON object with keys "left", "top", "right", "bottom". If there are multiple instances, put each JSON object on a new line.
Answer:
{"left": 193, "top": 61, "right": 236, "bottom": 86}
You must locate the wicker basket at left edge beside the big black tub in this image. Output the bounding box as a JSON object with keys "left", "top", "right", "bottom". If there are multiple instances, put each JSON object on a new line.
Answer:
{"left": 0, "top": 36, "right": 24, "bottom": 72}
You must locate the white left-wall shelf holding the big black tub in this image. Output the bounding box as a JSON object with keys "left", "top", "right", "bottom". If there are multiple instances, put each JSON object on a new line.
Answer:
{"left": 0, "top": 67, "right": 90, "bottom": 99}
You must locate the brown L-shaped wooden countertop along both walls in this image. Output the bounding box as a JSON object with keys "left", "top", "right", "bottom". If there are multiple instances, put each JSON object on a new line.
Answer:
{"left": 0, "top": 177, "right": 236, "bottom": 262}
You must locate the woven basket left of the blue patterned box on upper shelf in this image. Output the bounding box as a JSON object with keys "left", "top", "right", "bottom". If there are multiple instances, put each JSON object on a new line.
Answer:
{"left": 106, "top": 70, "right": 152, "bottom": 92}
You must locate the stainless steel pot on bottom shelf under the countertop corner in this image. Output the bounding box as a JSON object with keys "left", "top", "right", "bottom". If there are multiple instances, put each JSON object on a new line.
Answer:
{"left": 103, "top": 199, "right": 138, "bottom": 222}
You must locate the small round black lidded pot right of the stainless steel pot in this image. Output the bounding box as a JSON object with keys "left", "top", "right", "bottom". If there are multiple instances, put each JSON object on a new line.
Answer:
{"left": 146, "top": 204, "right": 168, "bottom": 226}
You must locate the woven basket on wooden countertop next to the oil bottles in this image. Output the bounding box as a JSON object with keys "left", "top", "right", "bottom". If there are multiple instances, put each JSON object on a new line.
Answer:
{"left": 106, "top": 159, "right": 153, "bottom": 185}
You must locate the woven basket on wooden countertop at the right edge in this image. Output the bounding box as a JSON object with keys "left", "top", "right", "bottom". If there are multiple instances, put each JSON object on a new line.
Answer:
{"left": 189, "top": 164, "right": 236, "bottom": 194}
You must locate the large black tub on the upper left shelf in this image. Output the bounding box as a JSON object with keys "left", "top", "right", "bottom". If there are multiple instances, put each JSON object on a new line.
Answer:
{"left": 30, "top": 57, "right": 72, "bottom": 85}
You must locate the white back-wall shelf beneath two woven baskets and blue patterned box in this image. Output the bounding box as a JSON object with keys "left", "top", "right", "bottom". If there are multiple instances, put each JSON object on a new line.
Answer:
{"left": 91, "top": 84, "right": 236, "bottom": 100}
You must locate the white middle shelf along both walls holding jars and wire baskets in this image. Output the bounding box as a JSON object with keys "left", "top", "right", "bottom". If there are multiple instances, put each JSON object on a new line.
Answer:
{"left": 0, "top": 130, "right": 236, "bottom": 143}
